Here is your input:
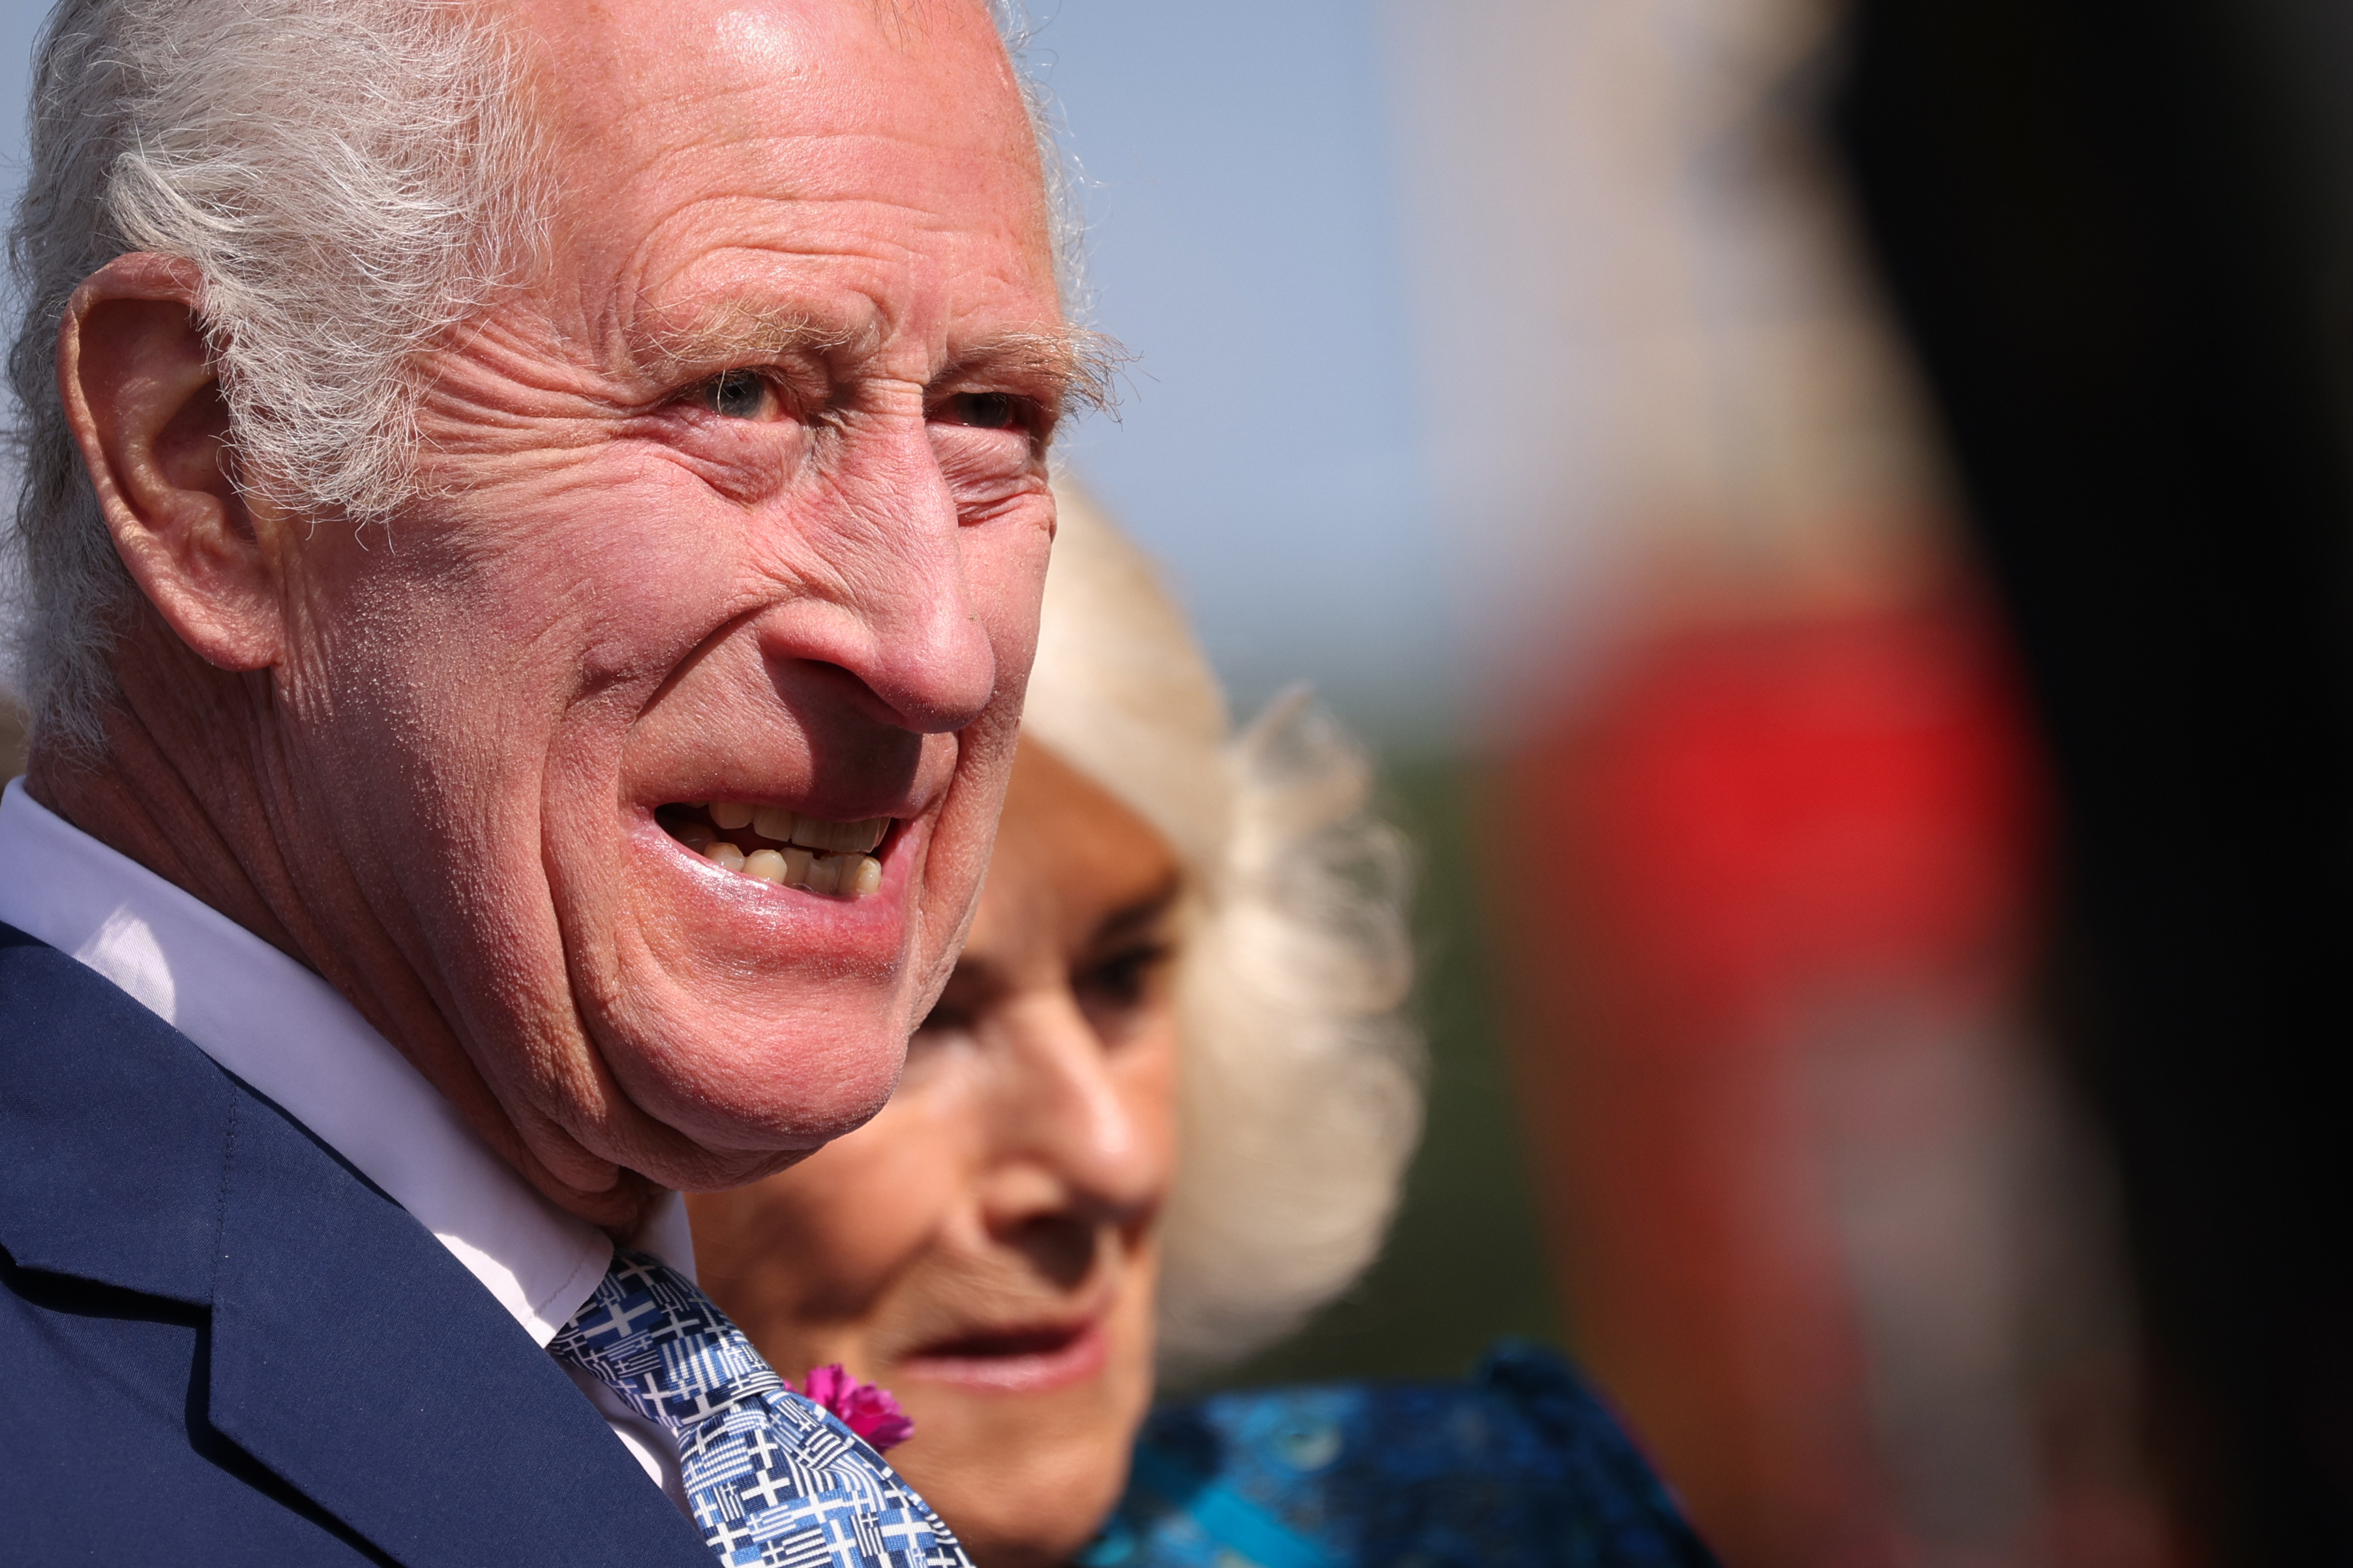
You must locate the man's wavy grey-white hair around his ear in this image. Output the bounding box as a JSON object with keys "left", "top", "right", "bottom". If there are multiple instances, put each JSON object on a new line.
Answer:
{"left": 0, "top": 0, "right": 1077, "bottom": 745}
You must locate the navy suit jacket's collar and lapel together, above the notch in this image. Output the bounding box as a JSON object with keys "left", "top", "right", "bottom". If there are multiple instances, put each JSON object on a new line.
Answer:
{"left": 0, "top": 926, "right": 711, "bottom": 1568}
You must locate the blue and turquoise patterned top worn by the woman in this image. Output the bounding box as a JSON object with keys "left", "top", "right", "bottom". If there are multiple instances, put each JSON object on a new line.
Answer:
{"left": 1077, "top": 1342, "right": 1715, "bottom": 1568}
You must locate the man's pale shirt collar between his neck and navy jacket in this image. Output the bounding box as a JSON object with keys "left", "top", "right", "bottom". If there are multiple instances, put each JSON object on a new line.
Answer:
{"left": 0, "top": 778, "right": 694, "bottom": 1344}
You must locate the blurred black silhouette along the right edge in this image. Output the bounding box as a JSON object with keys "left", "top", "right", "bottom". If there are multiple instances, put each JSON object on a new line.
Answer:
{"left": 1838, "top": 0, "right": 2353, "bottom": 1563}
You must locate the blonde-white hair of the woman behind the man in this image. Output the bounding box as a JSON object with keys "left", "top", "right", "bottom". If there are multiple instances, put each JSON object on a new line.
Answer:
{"left": 1021, "top": 484, "right": 1421, "bottom": 1375}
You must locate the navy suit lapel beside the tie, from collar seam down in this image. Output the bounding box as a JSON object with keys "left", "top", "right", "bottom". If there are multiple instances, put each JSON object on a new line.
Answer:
{"left": 207, "top": 1098, "right": 711, "bottom": 1568}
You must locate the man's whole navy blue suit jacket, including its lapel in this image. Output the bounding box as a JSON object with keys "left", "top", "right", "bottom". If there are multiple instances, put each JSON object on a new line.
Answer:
{"left": 0, "top": 926, "right": 711, "bottom": 1568}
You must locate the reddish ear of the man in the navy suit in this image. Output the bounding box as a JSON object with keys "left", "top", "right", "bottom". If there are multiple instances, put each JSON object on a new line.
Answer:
{"left": 57, "top": 254, "right": 285, "bottom": 670}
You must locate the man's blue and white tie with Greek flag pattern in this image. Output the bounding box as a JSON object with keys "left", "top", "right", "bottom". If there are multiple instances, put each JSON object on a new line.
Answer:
{"left": 548, "top": 1253, "right": 972, "bottom": 1568}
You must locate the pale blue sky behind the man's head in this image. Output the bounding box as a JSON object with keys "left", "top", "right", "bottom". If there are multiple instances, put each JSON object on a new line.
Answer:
{"left": 0, "top": 0, "right": 1450, "bottom": 736}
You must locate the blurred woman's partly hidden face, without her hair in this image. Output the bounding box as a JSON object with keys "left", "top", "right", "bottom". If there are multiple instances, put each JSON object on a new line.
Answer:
{"left": 689, "top": 745, "right": 1181, "bottom": 1568}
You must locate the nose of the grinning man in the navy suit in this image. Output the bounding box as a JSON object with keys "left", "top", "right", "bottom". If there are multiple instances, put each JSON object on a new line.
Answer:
{"left": 774, "top": 419, "right": 998, "bottom": 733}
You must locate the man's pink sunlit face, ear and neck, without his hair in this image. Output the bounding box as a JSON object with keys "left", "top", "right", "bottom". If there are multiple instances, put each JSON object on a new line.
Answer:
{"left": 31, "top": 0, "right": 1073, "bottom": 1232}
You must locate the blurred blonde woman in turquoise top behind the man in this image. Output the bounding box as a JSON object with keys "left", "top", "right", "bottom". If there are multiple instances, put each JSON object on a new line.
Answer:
{"left": 692, "top": 494, "right": 1706, "bottom": 1568}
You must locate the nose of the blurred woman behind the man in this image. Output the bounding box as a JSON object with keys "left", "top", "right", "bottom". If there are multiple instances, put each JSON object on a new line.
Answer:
{"left": 982, "top": 990, "right": 1172, "bottom": 1232}
